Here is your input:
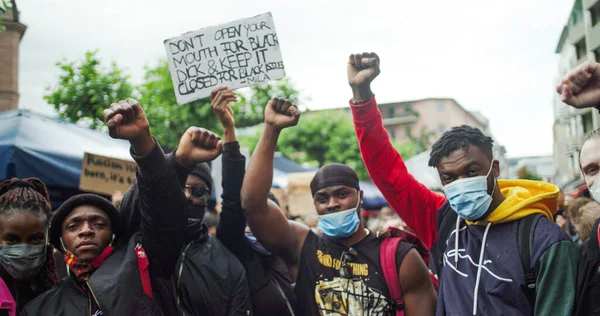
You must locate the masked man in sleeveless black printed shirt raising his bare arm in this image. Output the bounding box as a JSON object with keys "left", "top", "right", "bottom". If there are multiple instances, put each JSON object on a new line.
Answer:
{"left": 241, "top": 99, "right": 436, "bottom": 315}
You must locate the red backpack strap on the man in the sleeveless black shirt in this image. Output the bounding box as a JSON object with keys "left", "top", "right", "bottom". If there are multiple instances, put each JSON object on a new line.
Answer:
{"left": 379, "top": 237, "right": 404, "bottom": 316}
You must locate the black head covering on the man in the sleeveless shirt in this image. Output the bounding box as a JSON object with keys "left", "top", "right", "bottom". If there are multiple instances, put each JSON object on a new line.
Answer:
{"left": 310, "top": 163, "right": 360, "bottom": 196}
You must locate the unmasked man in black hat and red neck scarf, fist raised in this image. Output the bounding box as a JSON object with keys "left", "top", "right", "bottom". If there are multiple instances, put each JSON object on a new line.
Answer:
{"left": 25, "top": 99, "right": 185, "bottom": 316}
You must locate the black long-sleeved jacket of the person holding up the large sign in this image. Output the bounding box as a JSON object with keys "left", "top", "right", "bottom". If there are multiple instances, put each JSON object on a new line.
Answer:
{"left": 217, "top": 142, "right": 296, "bottom": 315}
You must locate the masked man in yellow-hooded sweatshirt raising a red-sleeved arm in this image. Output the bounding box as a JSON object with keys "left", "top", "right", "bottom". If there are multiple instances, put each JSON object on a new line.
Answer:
{"left": 347, "top": 53, "right": 579, "bottom": 315}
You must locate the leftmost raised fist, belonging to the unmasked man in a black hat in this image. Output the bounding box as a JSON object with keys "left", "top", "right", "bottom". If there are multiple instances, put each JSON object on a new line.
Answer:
{"left": 104, "top": 99, "right": 154, "bottom": 156}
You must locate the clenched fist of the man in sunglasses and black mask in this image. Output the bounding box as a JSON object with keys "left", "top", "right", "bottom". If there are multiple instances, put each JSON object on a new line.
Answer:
{"left": 175, "top": 126, "right": 223, "bottom": 168}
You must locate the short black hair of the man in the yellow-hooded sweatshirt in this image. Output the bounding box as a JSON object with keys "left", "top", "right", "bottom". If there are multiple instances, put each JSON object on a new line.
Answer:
{"left": 429, "top": 125, "right": 494, "bottom": 167}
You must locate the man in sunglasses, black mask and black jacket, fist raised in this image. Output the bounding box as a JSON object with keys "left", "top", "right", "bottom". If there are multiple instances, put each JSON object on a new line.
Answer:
{"left": 120, "top": 123, "right": 252, "bottom": 316}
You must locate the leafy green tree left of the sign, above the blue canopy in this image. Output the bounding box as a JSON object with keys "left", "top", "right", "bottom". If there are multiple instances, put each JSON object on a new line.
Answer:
{"left": 44, "top": 51, "right": 133, "bottom": 129}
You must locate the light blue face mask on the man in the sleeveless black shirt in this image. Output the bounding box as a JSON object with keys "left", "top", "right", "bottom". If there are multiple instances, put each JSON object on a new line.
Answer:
{"left": 318, "top": 199, "right": 360, "bottom": 238}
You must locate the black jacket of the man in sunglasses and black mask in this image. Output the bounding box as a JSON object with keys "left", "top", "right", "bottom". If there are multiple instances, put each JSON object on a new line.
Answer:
{"left": 120, "top": 149, "right": 252, "bottom": 316}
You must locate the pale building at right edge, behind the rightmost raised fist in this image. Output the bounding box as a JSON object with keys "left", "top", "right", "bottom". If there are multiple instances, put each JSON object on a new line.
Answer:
{"left": 552, "top": 0, "right": 600, "bottom": 186}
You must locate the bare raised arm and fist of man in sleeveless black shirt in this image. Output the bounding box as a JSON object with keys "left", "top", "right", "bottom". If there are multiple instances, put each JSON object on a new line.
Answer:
{"left": 242, "top": 99, "right": 309, "bottom": 265}
